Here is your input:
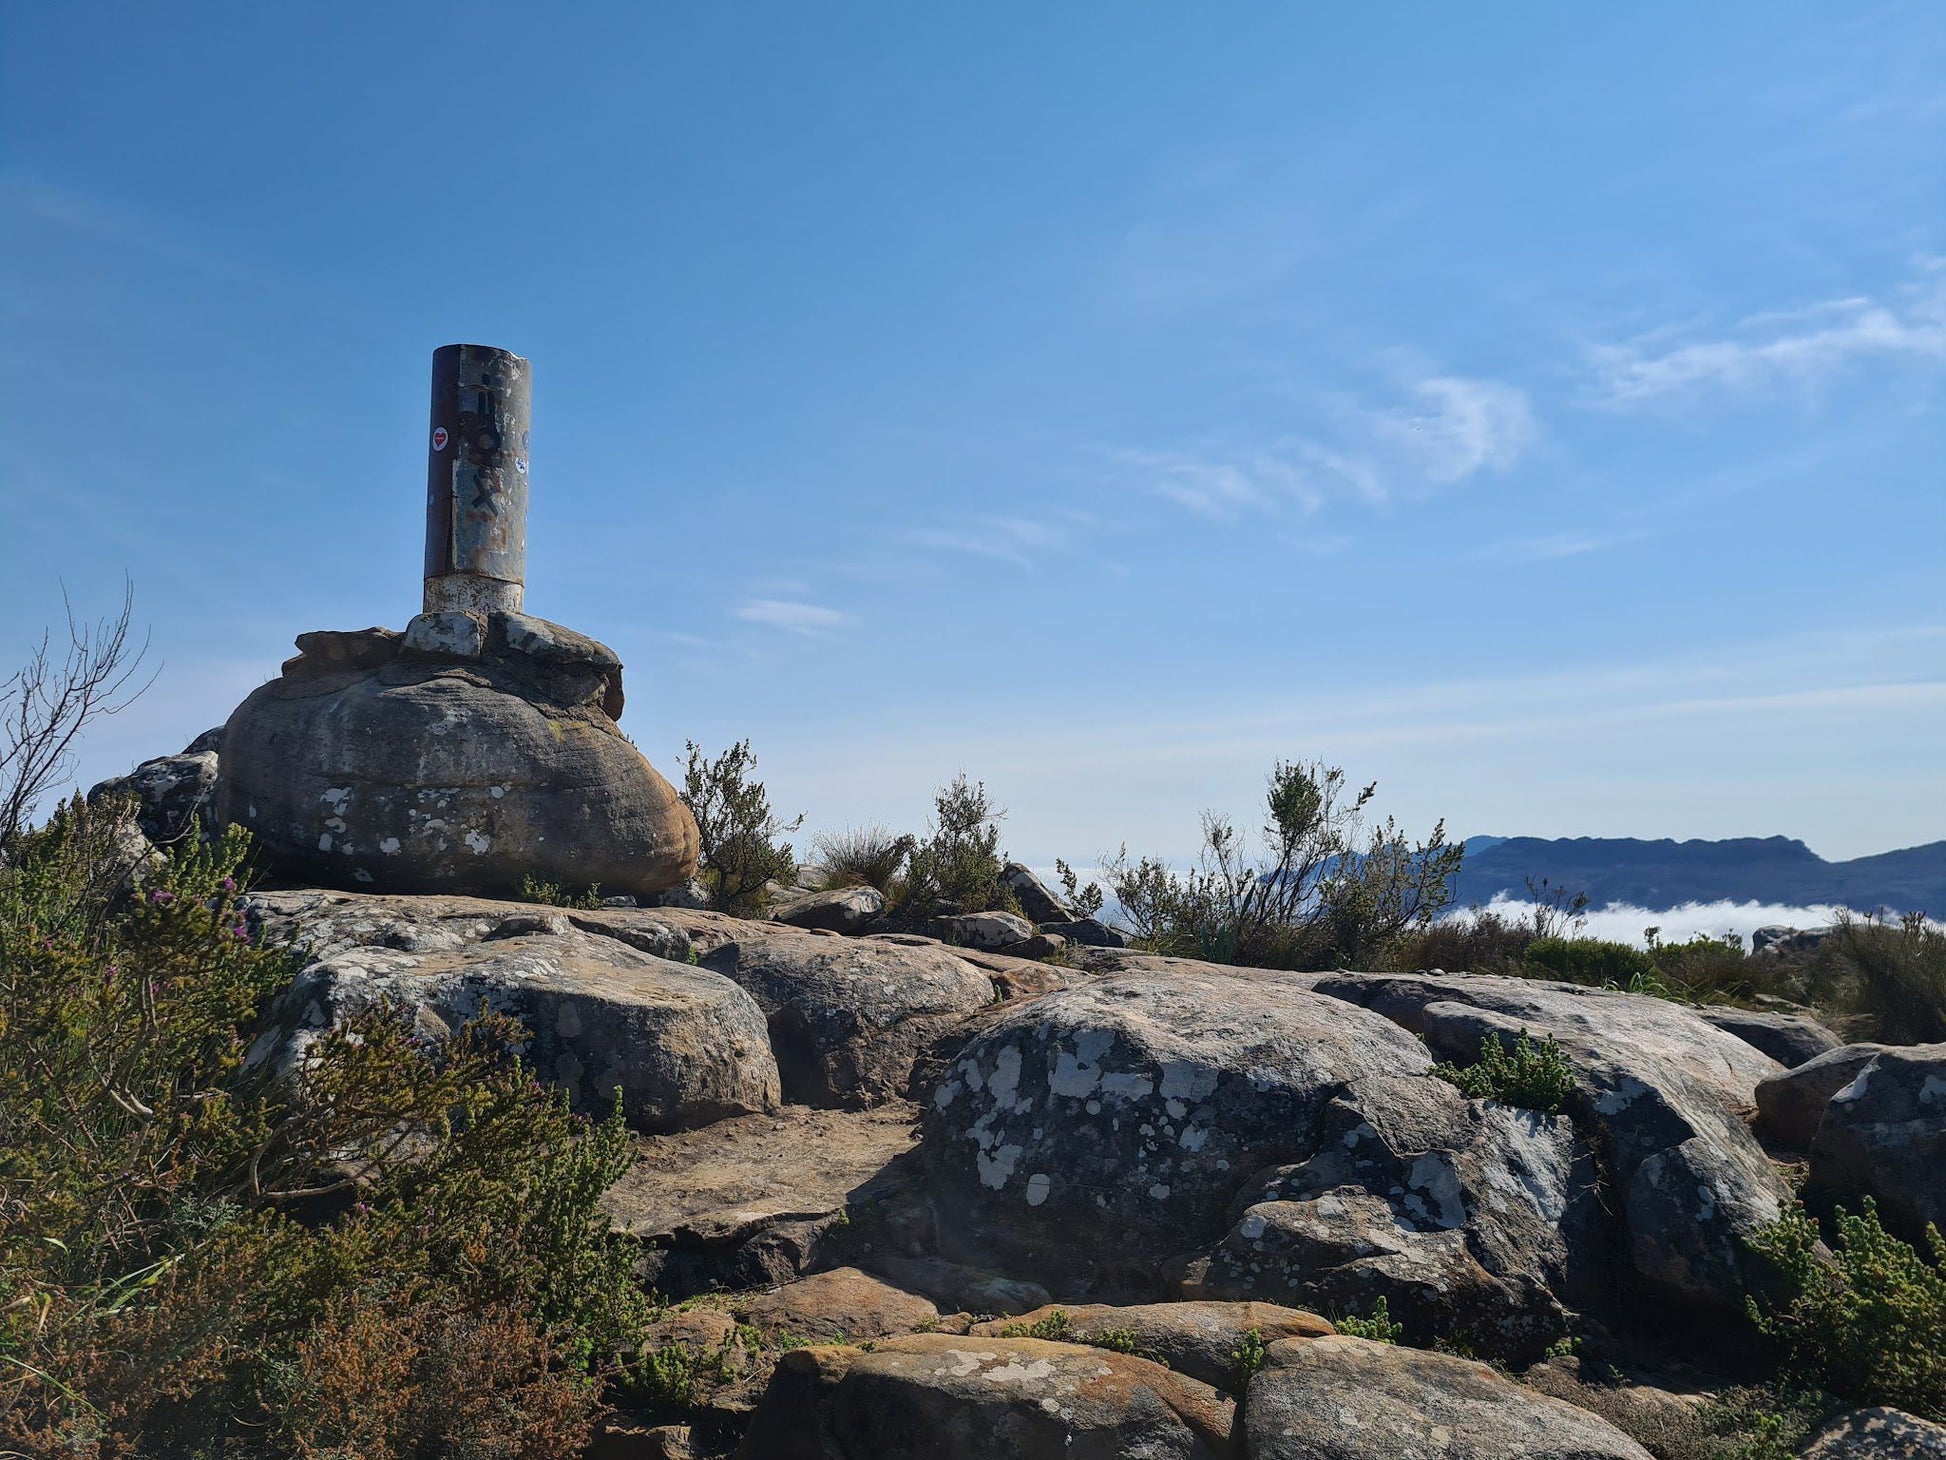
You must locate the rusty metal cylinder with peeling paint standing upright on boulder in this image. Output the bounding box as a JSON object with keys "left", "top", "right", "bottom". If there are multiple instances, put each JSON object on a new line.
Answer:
{"left": 426, "top": 345, "right": 533, "bottom": 613}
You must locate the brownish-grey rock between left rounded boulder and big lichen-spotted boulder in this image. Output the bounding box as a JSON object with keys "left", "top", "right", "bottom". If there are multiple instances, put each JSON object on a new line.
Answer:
{"left": 703, "top": 923, "right": 992, "bottom": 1106}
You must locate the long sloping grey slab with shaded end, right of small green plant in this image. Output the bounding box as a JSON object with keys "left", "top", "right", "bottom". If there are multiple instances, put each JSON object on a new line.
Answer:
{"left": 1315, "top": 973, "right": 1788, "bottom": 1308}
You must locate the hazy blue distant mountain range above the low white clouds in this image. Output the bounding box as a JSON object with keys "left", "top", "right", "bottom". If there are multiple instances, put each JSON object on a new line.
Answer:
{"left": 1458, "top": 837, "right": 1946, "bottom": 917}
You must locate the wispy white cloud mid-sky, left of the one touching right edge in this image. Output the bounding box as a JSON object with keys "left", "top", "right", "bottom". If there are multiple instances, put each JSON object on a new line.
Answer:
{"left": 1113, "top": 376, "right": 1539, "bottom": 522}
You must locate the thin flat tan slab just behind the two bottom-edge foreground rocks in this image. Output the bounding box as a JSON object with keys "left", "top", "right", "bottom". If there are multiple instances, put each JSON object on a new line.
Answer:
{"left": 967, "top": 1302, "right": 1337, "bottom": 1394}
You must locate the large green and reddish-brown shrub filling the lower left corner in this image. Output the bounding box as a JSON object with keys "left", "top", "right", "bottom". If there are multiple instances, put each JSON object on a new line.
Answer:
{"left": 0, "top": 804, "right": 646, "bottom": 1460}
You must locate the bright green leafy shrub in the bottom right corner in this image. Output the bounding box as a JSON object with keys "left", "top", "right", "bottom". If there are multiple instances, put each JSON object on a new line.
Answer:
{"left": 1749, "top": 1197, "right": 1946, "bottom": 1419}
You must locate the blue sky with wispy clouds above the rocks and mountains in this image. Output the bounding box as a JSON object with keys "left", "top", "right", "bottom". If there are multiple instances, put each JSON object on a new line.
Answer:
{"left": 0, "top": 0, "right": 1946, "bottom": 860}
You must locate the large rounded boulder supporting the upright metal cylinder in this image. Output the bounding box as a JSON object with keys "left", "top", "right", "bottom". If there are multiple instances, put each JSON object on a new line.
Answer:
{"left": 216, "top": 613, "right": 697, "bottom": 895}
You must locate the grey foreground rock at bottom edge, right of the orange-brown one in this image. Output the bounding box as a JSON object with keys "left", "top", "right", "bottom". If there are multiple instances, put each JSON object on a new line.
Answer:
{"left": 1242, "top": 1337, "right": 1650, "bottom": 1460}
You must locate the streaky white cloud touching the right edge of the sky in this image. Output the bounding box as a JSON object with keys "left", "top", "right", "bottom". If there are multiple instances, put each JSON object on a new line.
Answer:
{"left": 1590, "top": 261, "right": 1946, "bottom": 407}
